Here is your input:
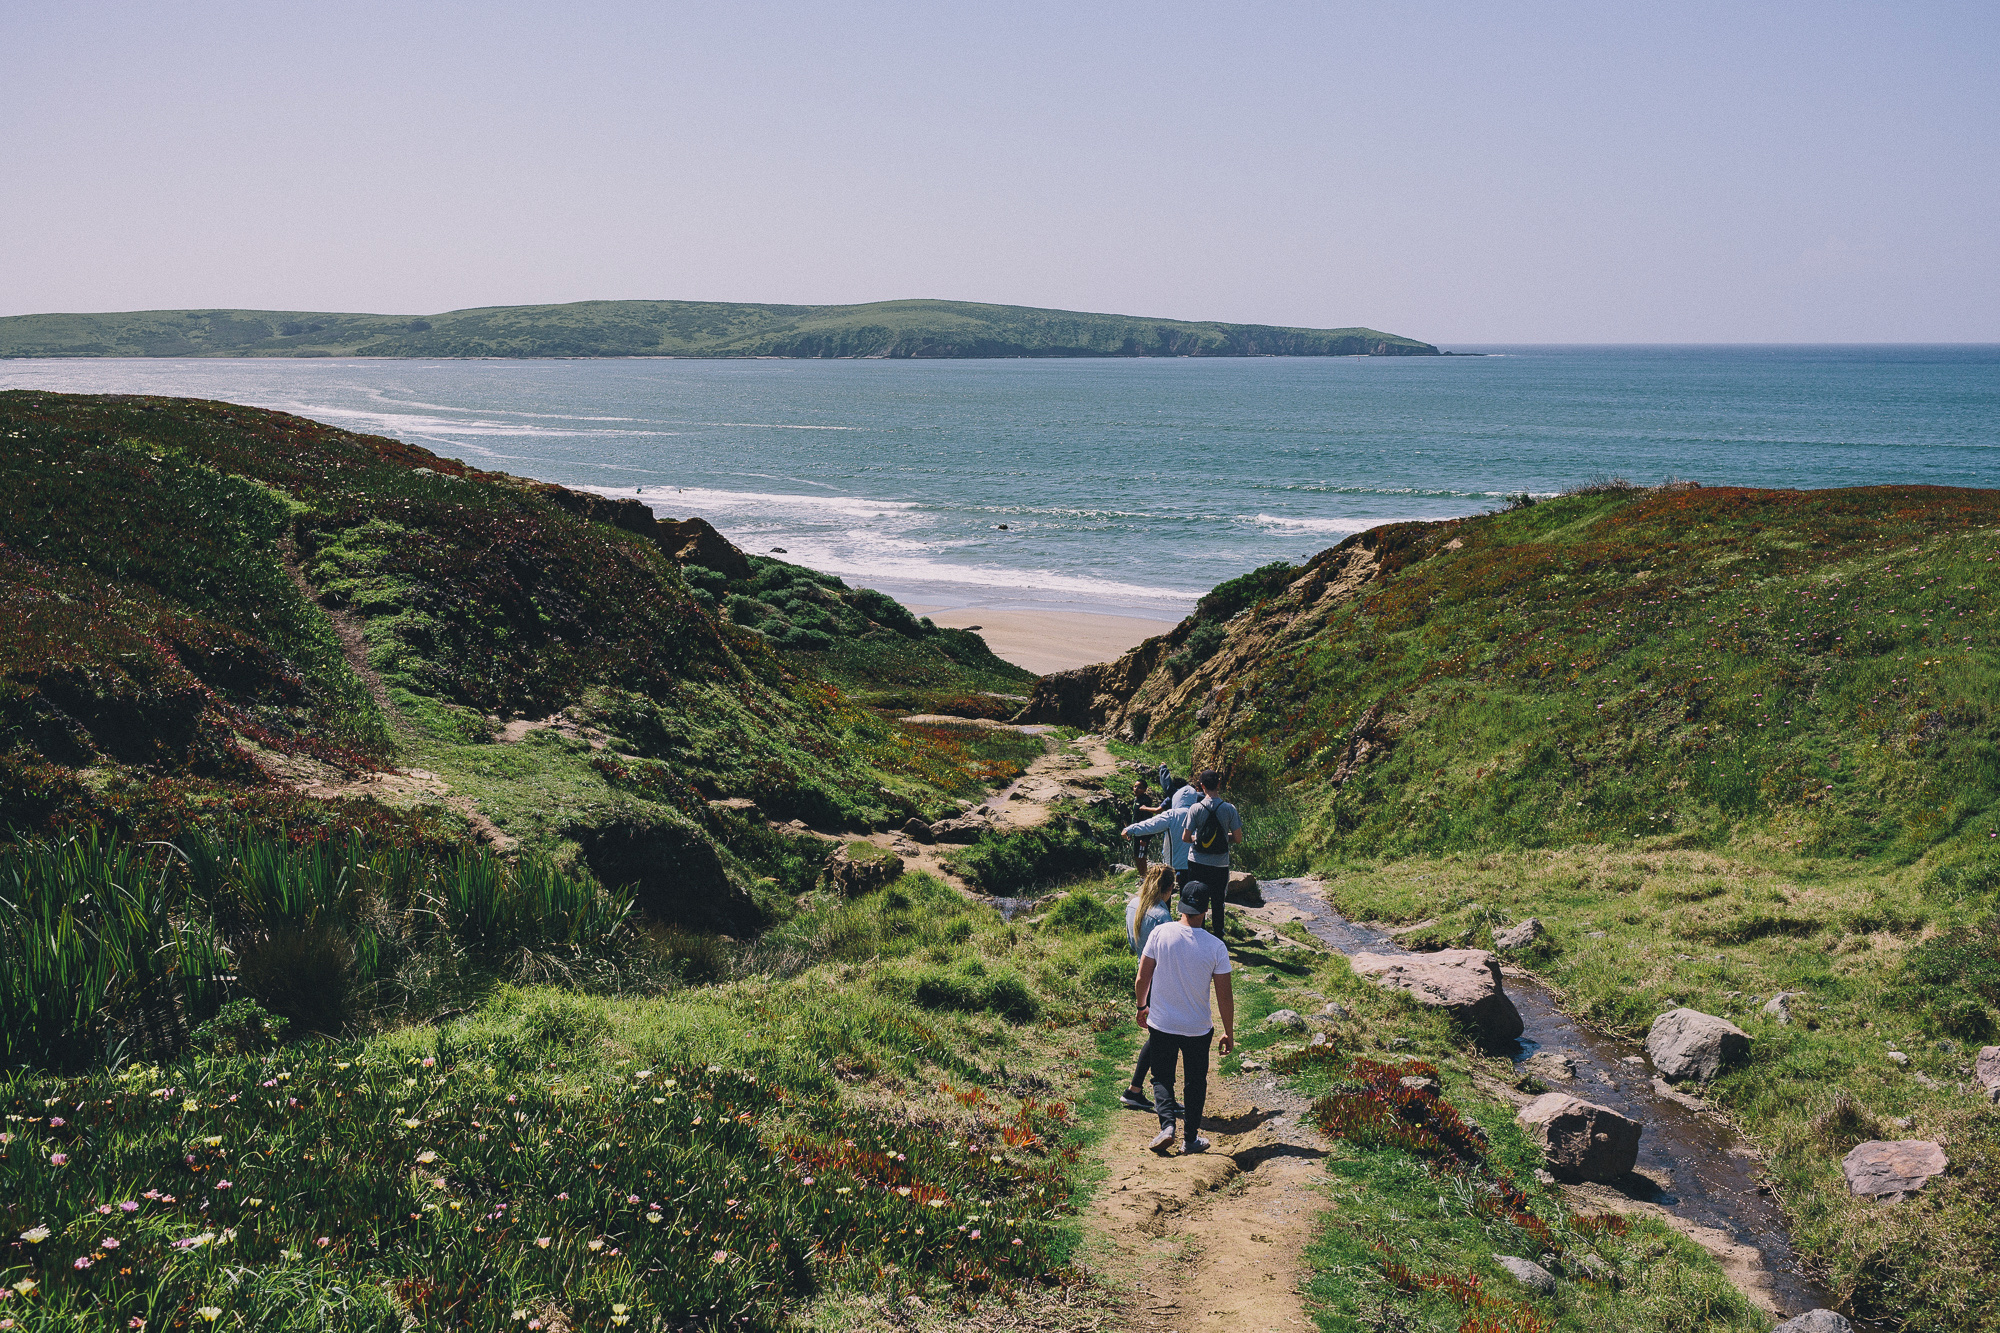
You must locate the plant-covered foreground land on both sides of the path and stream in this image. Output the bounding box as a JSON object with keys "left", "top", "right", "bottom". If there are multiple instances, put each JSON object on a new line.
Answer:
{"left": 0, "top": 390, "right": 2000, "bottom": 1333}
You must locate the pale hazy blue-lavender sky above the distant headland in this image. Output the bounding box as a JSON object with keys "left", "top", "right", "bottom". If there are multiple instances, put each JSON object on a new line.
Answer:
{"left": 0, "top": 0, "right": 2000, "bottom": 342}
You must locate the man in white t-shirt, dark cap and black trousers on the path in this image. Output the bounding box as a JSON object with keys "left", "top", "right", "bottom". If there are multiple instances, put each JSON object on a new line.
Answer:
{"left": 1136, "top": 883, "right": 1236, "bottom": 1157}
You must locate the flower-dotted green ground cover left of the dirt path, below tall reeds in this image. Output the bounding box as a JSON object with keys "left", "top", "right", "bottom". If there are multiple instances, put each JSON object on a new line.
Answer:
{"left": 0, "top": 879, "right": 1130, "bottom": 1329}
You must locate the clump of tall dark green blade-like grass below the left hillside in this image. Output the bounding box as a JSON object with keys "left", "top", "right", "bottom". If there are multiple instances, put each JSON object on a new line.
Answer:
{"left": 0, "top": 833, "right": 632, "bottom": 1069}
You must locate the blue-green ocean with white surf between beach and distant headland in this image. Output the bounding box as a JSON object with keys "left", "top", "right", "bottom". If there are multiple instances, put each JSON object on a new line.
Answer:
{"left": 0, "top": 346, "right": 2000, "bottom": 618}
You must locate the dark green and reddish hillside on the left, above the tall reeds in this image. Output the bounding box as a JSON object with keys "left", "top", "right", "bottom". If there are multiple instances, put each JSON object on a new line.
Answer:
{"left": 0, "top": 392, "right": 1024, "bottom": 912}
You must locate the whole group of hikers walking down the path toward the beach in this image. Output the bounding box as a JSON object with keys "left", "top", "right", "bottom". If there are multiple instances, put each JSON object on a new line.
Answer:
{"left": 1118, "top": 765, "right": 1244, "bottom": 1157}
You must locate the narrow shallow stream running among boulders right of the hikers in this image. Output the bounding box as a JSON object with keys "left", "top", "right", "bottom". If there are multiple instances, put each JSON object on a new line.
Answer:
{"left": 1260, "top": 879, "right": 1860, "bottom": 1327}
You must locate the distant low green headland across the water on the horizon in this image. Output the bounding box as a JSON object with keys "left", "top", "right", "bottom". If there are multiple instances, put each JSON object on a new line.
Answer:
{"left": 0, "top": 300, "right": 1438, "bottom": 358}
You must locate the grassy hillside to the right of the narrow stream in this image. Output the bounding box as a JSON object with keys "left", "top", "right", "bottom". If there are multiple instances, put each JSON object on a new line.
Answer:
{"left": 1030, "top": 484, "right": 2000, "bottom": 1331}
